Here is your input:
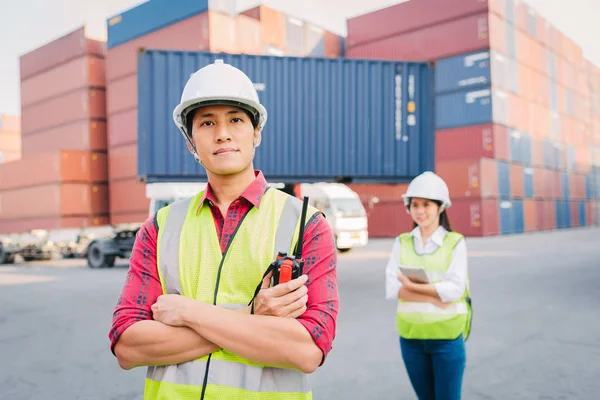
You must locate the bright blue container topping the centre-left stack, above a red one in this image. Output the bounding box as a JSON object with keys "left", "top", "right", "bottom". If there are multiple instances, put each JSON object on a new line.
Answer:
{"left": 106, "top": 0, "right": 208, "bottom": 49}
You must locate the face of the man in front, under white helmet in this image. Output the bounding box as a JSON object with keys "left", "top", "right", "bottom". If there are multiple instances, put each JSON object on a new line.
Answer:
{"left": 192, "top": 106, "right": 260, "bottom": 175}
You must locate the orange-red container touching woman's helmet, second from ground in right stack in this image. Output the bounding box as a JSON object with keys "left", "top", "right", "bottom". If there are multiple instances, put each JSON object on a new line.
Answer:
{"left": 436, "top": 158, "right": 498, "bottom": 198}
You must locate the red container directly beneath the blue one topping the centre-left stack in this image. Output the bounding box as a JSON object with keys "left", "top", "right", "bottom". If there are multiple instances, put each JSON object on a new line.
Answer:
{"left": 106, "top": 12, "right": 211, "bottom": 83}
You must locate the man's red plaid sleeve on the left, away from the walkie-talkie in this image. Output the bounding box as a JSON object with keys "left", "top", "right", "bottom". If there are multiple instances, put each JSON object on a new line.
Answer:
{"left": 108, "top": 217, "right": 162, "bottom": 354}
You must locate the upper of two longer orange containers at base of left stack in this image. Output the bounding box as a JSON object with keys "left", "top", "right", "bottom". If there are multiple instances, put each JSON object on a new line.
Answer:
{"left": 0, "top": 183, "right": 108, "bottom": 220}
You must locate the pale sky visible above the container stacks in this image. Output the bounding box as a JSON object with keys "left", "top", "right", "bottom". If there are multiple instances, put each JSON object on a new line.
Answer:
{"left": 0, "top": 0, "right": 600, "bottom": 114}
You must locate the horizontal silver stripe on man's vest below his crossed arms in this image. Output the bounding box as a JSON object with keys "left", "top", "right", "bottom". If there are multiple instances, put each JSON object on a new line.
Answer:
{"left": 146, "top": 360, "right": 310, "bottom": 392}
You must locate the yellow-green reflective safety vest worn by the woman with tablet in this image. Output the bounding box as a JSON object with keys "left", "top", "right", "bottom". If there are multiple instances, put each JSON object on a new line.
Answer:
{"left": 396, "top": 232, "right": 472, "bottom": 340}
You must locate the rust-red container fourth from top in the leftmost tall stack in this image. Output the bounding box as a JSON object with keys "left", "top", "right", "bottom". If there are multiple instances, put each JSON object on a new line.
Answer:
{"left": 23, "top": 120, "right": 106, "bottom": 157}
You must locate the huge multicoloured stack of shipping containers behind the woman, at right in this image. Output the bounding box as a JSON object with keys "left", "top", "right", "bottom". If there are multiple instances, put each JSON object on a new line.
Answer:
{"left": 347, "top": 0, "right": 600, "bottom": 236}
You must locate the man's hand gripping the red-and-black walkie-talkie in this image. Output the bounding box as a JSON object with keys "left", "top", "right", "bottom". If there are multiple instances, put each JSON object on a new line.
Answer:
{"left": 254, "top": 272, "right": 308, "bottom": 318}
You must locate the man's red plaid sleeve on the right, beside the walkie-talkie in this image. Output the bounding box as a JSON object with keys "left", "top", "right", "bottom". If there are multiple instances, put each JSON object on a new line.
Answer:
{"left": 298, "top": 214, "right": 339, "bottom": 365}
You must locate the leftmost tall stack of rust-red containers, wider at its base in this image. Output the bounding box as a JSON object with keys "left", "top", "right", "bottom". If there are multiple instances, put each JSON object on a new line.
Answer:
{"left": 0, "top": 28, "right": 108, "bottom": 232}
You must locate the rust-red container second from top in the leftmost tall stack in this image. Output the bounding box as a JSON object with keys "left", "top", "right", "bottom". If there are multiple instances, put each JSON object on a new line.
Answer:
{"left": 21, "top": 56, "right": 106, "bottom": 107}
